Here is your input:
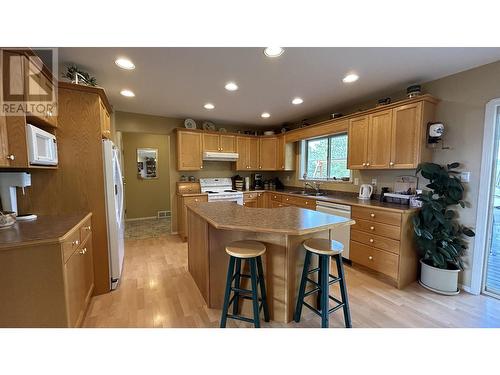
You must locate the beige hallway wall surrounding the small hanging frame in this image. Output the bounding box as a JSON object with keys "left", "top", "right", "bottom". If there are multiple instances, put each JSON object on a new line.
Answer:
{"left": 121, "top": 132, "right": 170, "bottom": 219}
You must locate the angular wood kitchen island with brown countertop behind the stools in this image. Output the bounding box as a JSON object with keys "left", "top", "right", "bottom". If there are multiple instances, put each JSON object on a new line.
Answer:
{"left": 187, "top": 202, "right": 355, "bottom": 323}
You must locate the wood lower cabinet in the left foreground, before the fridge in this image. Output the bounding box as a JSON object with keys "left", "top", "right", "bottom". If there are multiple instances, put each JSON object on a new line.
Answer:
{"left": 0, "top": 214, "right": 94, "bottom": 327}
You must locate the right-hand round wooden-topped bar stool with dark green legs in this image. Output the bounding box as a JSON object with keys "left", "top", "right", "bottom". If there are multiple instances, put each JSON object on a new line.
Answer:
{"left": 294, "top": 238, "right": 352, "bottom": 328}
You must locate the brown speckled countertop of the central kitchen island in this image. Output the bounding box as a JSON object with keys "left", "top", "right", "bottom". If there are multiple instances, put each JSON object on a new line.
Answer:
{"left": 187, "top": 202, "right": 355, "bottom": 236}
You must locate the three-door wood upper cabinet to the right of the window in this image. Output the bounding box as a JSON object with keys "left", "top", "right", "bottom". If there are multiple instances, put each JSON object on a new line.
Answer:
{"left": 348, "top": 100, "right": 436, "bottom": 169}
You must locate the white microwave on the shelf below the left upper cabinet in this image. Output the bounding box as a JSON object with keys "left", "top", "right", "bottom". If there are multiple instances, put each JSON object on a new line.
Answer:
{"left": 26, "top": 124, "right": 58, "bottom": 165}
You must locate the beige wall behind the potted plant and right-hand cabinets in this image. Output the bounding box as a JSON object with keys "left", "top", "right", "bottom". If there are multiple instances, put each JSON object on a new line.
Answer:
{"left": 283, "top": 62, "right": 500, "bottom": 287}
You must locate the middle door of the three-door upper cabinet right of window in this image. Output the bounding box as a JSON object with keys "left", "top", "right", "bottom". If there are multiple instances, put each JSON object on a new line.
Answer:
{"left": 368, "top": 109, "right": 392, "bottom": 169}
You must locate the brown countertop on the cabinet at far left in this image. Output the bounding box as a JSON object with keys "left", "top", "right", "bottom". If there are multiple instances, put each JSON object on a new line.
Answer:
{"left": 0, "top": 213, "right": 92, "bottom": 251}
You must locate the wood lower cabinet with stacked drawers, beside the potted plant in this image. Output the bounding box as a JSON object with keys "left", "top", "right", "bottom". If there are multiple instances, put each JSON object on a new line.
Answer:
{"left": 349, "top": 206, "right": 418, "bottom": 288}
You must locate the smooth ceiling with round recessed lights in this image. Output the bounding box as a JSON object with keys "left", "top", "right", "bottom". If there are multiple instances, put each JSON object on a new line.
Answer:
{"left": 59, "top": 48, "right": 500, "bottom": 127}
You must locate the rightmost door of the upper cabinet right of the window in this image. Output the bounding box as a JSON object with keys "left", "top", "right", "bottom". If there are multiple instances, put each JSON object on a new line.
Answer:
{"left": 389, "top": 103, "right": 423, "bottom": 169}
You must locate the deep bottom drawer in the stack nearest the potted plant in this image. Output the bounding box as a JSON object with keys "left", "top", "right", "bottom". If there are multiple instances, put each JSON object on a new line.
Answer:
{"left": 349, "top": 241, "right": 399, "bottom": 279}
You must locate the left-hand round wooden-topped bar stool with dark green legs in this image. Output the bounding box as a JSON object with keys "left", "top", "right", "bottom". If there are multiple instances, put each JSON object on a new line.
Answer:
{"left": 220, "top": 241, "right": 269, "bottom": 328}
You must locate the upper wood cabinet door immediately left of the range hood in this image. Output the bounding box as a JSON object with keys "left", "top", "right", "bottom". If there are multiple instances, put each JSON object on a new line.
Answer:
{"left": 177, "top": 131, "right": 203, "bottom": 171}
